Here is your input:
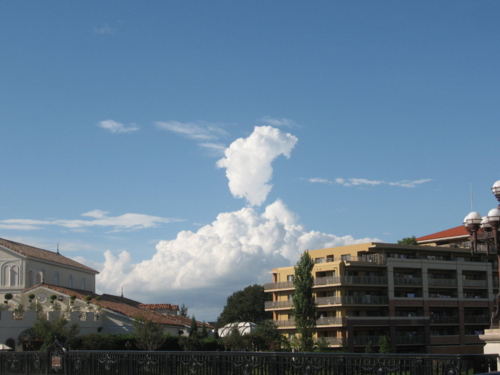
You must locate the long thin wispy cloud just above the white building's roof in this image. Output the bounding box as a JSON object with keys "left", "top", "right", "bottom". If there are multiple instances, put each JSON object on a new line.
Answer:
{"left": 0, "top": 210, "right": 184, "bottom": 232}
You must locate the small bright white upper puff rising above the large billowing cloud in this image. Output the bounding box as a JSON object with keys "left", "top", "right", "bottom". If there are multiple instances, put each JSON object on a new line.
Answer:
{"left": 217, "top": 126, "right": 297, "bottom": 206}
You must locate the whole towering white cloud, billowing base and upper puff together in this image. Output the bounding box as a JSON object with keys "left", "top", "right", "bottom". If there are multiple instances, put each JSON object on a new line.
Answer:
{"left": 98, "top": 126, "right": 376, "bottom": 319}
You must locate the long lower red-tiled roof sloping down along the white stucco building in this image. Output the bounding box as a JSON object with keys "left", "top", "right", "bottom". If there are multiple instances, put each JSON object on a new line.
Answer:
{"left": 24, "top": 283, "right": 211, "bottom": 328}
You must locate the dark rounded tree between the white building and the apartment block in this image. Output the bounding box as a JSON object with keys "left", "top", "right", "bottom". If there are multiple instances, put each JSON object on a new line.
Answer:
{"left": 217, "top": 284, "right": 272, "bottom": 327}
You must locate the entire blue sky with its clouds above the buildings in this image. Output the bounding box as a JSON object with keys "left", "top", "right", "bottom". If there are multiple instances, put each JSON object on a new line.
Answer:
{"left": 0, "top": 1, "right": 500, "bottom": 320}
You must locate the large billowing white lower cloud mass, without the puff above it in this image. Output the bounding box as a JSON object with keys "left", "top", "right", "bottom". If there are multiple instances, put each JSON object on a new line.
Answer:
{"left": 98, "top": 200, "right": 379, "bottom": 308}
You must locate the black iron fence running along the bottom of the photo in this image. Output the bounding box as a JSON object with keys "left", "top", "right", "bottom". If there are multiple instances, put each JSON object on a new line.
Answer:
{"left": 0, "top": 348, "right": 498, "bottom": 375}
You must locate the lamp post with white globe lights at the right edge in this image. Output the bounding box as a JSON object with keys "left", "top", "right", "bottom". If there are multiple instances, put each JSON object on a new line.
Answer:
{"left": 464, "top": 181, "right": 500, "bottom": 328}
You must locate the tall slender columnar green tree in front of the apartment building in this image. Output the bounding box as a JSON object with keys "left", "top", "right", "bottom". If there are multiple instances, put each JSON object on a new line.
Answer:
{"left": 293, "top": 251, "right": 318, "bottom": 352}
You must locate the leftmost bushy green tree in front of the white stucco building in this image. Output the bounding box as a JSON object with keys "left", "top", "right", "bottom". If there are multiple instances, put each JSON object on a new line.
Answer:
{"left": 31, "top": 313, "right": 80, "bottom": 350}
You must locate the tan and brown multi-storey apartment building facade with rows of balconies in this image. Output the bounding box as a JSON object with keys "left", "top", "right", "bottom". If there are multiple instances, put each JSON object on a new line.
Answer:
{"left": 264, "top": 241, "right": 498, "bottom": 354}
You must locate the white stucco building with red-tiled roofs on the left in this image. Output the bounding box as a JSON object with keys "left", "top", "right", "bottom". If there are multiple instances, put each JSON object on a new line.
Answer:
{"left": 0, "top": 238, "right": 207, "bottom": 350}
